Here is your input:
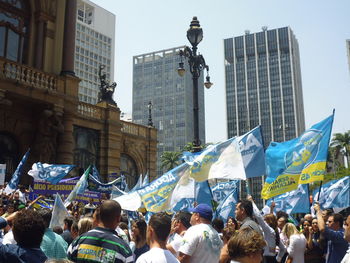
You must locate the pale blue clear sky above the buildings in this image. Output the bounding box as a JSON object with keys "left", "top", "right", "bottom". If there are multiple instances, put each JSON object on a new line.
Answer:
{"left": 92, "top": 0, "right": 350, "bottom": 142}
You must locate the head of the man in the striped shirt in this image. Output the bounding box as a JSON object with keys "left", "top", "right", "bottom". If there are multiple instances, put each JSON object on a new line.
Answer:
{"left": 100, "top": 200, "right": 122, "bottom": 230}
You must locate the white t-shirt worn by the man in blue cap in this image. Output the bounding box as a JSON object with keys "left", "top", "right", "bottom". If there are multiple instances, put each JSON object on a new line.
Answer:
{"left": 179, "top": 224, "right": 223, "bottom": 263}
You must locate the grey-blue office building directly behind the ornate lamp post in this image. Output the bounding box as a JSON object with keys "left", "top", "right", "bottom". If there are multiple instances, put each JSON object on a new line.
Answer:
{"left": 132, "top": 47, "right": 205, "bottom": 175}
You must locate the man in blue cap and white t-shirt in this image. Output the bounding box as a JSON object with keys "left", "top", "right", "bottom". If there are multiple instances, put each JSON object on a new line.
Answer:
{"left": 179, "top": 204, "right": 223, "bottom": 263}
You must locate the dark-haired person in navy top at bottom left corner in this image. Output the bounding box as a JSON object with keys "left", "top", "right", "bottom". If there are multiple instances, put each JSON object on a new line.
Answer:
{"left": 0, "top": 210, "right": 47, "bottom": 263}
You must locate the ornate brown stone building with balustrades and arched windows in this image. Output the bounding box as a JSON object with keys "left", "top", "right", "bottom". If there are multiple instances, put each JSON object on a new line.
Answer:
{"left": 0, "top": 0, "right": 157, "bottom": 186}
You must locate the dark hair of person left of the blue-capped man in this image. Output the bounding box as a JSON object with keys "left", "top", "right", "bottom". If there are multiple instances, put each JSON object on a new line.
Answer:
{"left": 148, "top": 212, "right": 171, "bottom": 242}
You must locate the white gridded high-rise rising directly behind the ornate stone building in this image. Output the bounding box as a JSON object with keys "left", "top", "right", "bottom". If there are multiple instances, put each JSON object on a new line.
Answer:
{"left": 74, "top": 0, "right": 115, "bottom": 104}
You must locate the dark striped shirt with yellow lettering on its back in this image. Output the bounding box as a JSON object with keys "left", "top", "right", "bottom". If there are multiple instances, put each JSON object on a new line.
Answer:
{"left": 68, "top": 227, "right": 134, "bottom": 263}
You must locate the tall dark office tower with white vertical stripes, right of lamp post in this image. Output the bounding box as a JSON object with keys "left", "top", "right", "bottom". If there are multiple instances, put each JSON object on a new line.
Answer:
{"left": 224, "top": 27, "right": 305, "bottom": 208}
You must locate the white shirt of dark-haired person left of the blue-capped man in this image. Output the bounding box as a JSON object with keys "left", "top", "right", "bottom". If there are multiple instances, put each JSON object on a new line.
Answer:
{"left": 136, "top": 247, "right": 180, "bottom": 263}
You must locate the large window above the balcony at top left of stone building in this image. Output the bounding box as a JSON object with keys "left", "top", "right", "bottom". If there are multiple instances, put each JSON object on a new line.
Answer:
{"left": 0, "top": 0, "right": 30, "bottom": 63}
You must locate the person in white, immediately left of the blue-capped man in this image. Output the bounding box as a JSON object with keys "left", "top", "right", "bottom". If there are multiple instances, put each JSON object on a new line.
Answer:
{"left": 166, "top": 211, "right": 191, "bottom": 257}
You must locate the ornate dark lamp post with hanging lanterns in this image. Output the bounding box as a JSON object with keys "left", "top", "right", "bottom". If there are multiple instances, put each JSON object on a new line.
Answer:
{"left": 177, "top": 17, "right": 213, "bottom": 152}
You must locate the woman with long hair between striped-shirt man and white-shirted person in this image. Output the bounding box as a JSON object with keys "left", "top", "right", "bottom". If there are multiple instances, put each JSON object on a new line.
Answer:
{"left": 130, "top": 219, "right": 149, "bottom": 261}
